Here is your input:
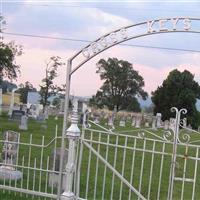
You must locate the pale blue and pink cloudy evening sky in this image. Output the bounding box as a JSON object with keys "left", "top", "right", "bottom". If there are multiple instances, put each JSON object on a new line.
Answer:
{"left": 0, "top": 0, "right": 200, "bottom": 96}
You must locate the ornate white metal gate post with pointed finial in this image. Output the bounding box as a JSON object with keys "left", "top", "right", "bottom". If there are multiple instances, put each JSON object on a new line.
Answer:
{"left": 60, "top": 100, "right": 80, "bottom": 200}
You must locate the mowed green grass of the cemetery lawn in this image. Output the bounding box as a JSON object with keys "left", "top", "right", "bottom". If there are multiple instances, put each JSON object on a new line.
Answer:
{"left": 0, "top": 115, "right": 200, "bottom": 200}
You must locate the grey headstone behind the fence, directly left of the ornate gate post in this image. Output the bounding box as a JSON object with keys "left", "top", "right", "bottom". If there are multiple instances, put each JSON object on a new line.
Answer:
{"left": 49, "top": 149, "right": 68, "bottom": 190}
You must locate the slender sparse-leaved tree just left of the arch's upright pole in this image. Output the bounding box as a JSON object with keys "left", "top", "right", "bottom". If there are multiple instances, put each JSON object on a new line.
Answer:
{"left": 39, "top": 56, "right": 64, "bottom": 111}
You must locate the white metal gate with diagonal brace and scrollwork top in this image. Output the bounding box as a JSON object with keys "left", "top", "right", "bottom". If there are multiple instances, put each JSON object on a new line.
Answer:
{"left": 76, "top": 108, "right": 200, "bottom": 200}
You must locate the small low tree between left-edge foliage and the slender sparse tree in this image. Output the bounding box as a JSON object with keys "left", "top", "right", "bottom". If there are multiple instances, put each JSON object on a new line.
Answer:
{"left": 17, "top": 81, "right": 37, "bottom": 103}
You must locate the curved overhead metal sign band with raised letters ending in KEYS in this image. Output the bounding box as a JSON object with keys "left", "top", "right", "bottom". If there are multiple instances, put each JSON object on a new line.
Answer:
{"left": 70, "top": 17, "right": 200, "bottom": 75}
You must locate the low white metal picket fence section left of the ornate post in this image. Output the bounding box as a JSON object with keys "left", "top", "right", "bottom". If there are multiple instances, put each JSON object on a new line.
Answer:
{"left": 0, "top": 125, "right": 67, "bottom": 199}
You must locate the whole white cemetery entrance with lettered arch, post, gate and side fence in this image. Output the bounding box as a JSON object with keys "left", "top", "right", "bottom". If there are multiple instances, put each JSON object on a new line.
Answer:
{"left": 0, "top": 17, "right": 200, "bottom": 200}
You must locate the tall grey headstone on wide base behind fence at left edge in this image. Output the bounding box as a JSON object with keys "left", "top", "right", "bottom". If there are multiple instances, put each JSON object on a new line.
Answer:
{"left": 0, "top": 131, "right": 22, "bottom": 180}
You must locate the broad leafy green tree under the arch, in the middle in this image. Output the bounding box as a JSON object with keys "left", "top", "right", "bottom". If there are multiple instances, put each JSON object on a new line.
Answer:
{"left": 90, "top": 58, "right": 148, "bottom": 111}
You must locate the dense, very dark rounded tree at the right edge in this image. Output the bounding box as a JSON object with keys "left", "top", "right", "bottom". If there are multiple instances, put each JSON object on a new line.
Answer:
{"left": 152, "top": 69, "right": 200, "bottom": 127}
